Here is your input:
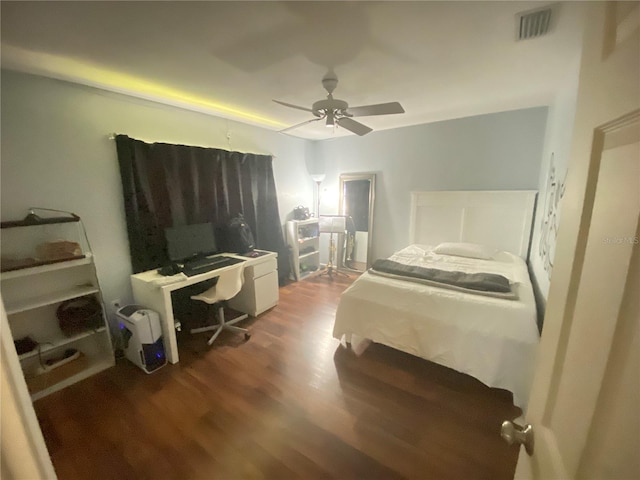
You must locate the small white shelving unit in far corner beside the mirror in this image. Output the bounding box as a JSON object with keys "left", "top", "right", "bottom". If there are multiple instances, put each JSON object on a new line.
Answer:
{"left": 287, "top": 218, "right": 320, "bottom": 280}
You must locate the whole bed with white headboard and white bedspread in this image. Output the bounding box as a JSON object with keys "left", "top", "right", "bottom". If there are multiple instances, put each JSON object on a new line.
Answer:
{"left": 333, "top": 191, "right": 539, "bottom": 411}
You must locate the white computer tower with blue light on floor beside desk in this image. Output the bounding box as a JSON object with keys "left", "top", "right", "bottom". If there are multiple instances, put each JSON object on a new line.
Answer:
{"left": 116, "top": 305, "right": 167, "bottom": 373}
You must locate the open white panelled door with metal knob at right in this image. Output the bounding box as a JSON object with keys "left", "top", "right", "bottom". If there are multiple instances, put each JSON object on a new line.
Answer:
{"left": 516, "top": 2, "right": 640, "bottom": 480}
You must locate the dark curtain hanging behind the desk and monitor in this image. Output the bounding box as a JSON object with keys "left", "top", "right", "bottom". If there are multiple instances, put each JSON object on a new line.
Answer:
{"left": 116, "top": 135, "right": 289, "bottom": 279}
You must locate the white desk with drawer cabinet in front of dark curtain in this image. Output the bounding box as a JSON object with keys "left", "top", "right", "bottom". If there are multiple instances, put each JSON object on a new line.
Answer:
{"left": 131, "top": 251, "right": 279, "bottom": 363}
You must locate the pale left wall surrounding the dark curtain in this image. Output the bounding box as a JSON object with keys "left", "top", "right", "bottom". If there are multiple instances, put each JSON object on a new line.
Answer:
{"left": 1, "top": 71, "right": 315, "bottom": 314}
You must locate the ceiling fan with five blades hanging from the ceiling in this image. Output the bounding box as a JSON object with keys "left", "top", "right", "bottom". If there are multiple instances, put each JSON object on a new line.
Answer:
{"left": 274, "top": 72, "right": 404, "bottom": 136}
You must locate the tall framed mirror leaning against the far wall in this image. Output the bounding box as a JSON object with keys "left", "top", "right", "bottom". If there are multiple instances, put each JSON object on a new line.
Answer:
{"left": 339, "top": 173, "right": 376, "bottom": 272}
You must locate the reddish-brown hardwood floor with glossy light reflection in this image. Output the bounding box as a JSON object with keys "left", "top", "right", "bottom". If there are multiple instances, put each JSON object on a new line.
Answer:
{"left": 35, "top": 276, "right": 520, "bottom": 480}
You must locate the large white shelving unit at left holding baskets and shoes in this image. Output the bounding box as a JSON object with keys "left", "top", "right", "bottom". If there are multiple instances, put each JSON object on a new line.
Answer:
{"left": 0, "top": 217, "right": 115, "bottom": 401}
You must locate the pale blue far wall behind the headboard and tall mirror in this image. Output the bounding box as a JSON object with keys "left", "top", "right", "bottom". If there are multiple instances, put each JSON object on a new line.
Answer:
{"left": 318, "top": 107, "right": 547, "bottom": 258}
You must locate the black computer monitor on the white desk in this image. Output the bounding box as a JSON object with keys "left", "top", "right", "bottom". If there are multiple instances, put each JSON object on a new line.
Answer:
{"left": 164, "top": 223, "right": 218, "bottom": 262}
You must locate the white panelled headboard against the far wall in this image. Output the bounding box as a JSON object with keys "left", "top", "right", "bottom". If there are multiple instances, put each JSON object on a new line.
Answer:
{"left": 409, "top": 190, "right": 536, "bottom": 260}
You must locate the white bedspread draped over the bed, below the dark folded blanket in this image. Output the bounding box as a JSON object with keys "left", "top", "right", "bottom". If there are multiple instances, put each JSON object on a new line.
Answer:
{"left": 333, "top": 245, "right": 539, "bottom": 411}
